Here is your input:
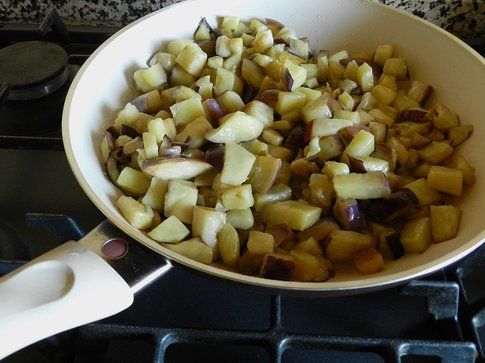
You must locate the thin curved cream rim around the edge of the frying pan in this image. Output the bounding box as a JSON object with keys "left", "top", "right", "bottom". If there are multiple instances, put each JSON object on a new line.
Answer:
{"left": 62, "top": 0, "right": 485, "bottom": 295}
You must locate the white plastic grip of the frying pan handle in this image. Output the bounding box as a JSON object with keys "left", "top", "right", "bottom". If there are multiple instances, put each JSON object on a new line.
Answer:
{"left": 0, "top": 242, "right": 133, "bottom": 359}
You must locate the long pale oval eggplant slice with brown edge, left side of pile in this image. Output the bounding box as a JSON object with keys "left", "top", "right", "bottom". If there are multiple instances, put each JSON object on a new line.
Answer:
{"left": 141, "top": 156, "right": 212, "bottom": 180}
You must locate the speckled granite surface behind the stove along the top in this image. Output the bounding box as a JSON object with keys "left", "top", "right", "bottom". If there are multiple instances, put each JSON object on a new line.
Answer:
{"left": 0, "top": 0, "right": 485, "bottom": 37}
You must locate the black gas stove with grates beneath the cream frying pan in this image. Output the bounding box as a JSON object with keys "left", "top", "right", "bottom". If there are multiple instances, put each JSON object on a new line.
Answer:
{"left": 0, "top": 10, "right": 485, "bottom": 363}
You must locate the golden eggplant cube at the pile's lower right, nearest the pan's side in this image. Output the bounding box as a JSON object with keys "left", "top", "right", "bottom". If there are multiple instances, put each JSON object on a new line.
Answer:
{"left": 430, "top": 205, "right": 461, "bottom": 242}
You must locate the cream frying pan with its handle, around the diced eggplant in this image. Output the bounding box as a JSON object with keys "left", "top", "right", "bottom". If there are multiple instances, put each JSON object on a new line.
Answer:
{"left": 0, "top": 0, "right": 485, "bottom": 358}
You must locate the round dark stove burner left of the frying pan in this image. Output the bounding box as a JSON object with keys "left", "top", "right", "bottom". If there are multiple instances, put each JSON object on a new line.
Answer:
{"left": 0, "top": 41, "right": 69, "bottom": 101}
